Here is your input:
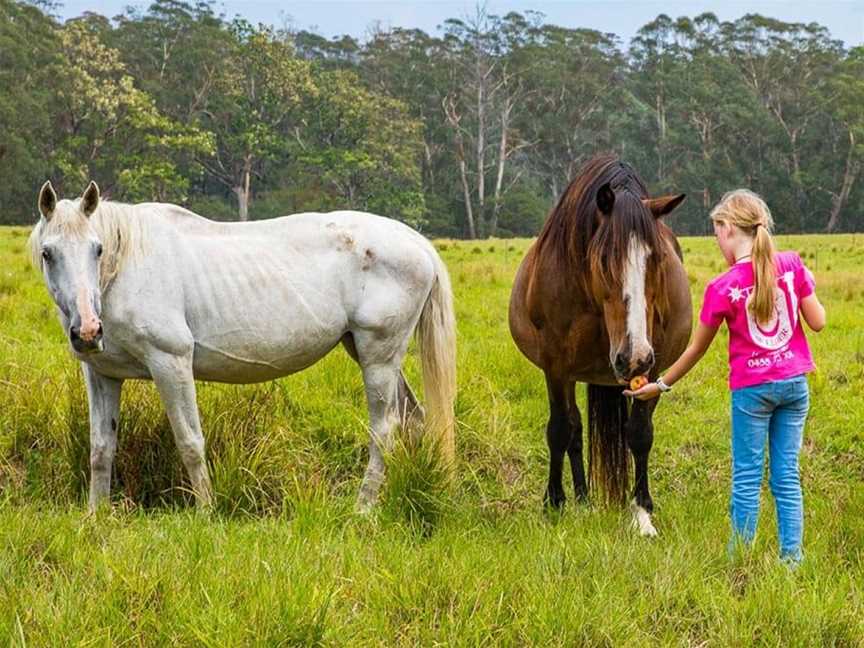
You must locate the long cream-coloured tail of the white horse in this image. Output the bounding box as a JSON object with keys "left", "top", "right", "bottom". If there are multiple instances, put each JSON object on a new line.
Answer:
{"left": 417, "top": 248, "right": 456, "bottom": 469}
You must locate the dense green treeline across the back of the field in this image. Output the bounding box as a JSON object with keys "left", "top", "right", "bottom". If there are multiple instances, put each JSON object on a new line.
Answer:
{"left": 0, "top": 0, "right": 864, "bottom": 237}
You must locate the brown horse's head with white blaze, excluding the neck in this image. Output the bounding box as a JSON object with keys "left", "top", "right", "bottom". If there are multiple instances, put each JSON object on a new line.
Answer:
{"left": 587, "top": 177, "right": 684, "bottom": 383}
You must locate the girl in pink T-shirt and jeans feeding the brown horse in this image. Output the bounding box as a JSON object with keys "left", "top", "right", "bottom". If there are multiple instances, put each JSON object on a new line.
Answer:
{"left": 624, "top": 189, "right": 825, "bottom": 563}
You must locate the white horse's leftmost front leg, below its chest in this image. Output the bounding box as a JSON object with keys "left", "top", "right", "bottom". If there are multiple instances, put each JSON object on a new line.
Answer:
{"left": 81, "top": 362, "right": 123, "bottom": 513}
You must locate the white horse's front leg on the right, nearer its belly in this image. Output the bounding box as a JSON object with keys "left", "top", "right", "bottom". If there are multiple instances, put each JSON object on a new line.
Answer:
{"left": 147, "top": 353, "right": 212, "bottom": 508}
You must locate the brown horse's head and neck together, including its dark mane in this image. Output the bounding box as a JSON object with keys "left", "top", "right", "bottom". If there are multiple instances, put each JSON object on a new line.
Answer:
{"left": 538, "top": 155, "right": 684, "bottom": 383}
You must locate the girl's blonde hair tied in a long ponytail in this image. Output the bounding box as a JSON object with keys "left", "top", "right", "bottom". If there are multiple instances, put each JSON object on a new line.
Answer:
{"left": 711, "top": 189, "right": 777, "bottom": 324}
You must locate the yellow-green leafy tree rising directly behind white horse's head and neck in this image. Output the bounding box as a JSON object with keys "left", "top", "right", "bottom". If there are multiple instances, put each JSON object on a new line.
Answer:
{"left": 50, "top": 16, "right": 213, "bottom": 200}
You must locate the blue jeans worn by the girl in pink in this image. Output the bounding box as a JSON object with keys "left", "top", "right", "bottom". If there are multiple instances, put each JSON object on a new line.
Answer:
{"left": 729, "top": 375, "right": 810, "bottom": 562}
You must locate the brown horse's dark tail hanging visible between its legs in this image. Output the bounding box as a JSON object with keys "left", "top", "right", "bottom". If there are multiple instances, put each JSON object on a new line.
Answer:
{"left": 588, "top": 385, "right": 630, "bottom": 504}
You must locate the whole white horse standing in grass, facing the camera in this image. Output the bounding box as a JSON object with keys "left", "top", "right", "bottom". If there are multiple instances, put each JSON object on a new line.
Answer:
{"left": 30, "top": 182, "right": 456, "bottom": 511}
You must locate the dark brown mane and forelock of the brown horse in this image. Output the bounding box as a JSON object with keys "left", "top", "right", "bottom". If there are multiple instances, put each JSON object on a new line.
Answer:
{"left": 537, "top": 155, "right": 668, "bottom": 286}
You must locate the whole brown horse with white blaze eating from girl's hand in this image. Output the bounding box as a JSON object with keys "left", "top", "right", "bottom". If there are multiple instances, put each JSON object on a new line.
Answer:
{"left": 510, "top": 156, "right": 692, "bottom": 536}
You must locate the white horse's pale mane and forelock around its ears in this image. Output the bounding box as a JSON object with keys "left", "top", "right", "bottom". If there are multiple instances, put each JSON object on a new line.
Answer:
{"left": 28, "top": 199, "right": 145, "bottom": 291}
